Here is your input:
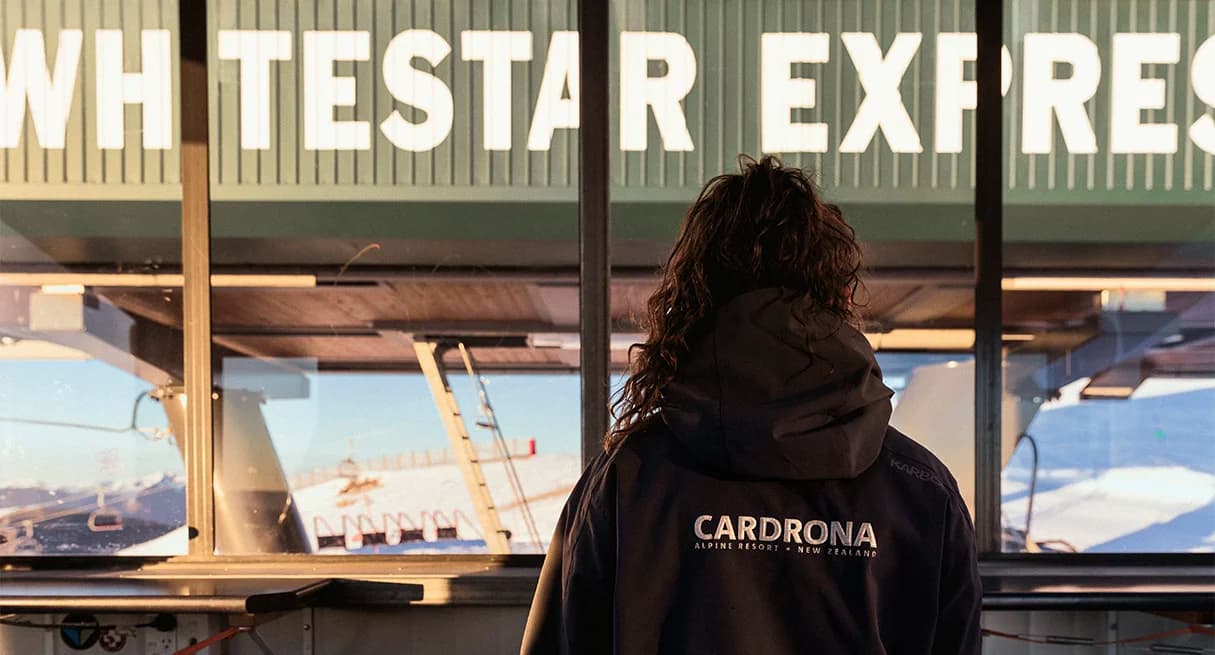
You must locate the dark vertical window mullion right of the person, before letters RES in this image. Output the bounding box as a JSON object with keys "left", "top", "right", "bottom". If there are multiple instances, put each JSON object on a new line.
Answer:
{"left": 974, "top": 0, "right": 1004, "bottom": 554}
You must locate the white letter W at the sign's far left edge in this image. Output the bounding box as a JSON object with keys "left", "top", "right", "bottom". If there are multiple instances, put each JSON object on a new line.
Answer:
{"left": 0, "top": 29, "right": 83, "bottom": 149}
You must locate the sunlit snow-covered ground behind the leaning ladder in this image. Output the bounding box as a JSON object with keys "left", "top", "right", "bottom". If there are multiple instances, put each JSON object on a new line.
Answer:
{"left": 293, "top": 454, "right": 582, "bottom": 554}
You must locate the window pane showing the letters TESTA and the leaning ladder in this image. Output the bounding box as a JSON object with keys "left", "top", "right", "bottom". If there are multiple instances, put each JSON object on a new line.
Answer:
{"left": 209, "top": 0, "right": 581, "bottom": 554}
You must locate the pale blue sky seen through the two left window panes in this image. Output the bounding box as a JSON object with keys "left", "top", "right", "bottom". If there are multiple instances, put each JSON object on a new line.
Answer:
{"left": 0, "top": 361, "right": 595, "bottom": 486}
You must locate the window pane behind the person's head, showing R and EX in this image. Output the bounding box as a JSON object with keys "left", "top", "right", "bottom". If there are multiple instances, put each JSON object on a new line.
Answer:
{"left": 611, "top": 0, "right": 974, "bottom": 501}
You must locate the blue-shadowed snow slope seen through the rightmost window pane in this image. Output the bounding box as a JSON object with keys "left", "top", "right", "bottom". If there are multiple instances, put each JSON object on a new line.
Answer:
{"left": 1002, "top": 380, "right": 1215, "bottom": 553}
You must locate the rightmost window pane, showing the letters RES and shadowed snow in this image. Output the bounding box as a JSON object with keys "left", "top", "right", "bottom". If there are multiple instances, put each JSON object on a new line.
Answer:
{"left": 1002, "top": 0, "right": 1215, "bottom": 553}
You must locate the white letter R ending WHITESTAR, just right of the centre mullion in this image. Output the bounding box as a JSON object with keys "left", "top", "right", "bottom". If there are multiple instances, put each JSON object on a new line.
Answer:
{"left": 620, "top": 32, "right": 696, "bottom": 151}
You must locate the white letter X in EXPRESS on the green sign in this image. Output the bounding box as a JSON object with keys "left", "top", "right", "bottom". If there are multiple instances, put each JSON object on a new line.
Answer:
{"left": 840, "top": 32, "right": 923, "bottom": 152}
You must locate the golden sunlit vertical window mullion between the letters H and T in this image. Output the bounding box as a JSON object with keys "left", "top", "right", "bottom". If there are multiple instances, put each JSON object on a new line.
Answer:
{"left": 177, "top": 0, "right": 215, "bottom": 558}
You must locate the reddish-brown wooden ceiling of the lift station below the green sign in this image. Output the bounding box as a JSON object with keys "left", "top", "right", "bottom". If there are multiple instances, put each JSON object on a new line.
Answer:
{"left": 95, "top": 277, "right": 1215, "bottom": 371}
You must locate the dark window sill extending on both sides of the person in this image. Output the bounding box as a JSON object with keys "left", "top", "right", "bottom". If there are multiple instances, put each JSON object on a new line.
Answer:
{"left": 5, "top": 557, "right": 1215, "bottom": 611}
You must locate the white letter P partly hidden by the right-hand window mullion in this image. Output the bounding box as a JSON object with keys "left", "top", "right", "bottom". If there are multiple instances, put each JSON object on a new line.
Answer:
{"left": 933, "top": 32, "right": 1012, "bottom": 153}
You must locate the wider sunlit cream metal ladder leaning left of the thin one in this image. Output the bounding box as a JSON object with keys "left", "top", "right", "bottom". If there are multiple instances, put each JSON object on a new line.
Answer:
{"left": 413, "top": 337, "right": 510, "bottom": 554}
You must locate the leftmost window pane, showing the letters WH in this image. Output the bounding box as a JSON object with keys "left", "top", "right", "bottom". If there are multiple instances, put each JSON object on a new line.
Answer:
{"left": 0, "top": 0, "right": 186, "bottom": 557}
